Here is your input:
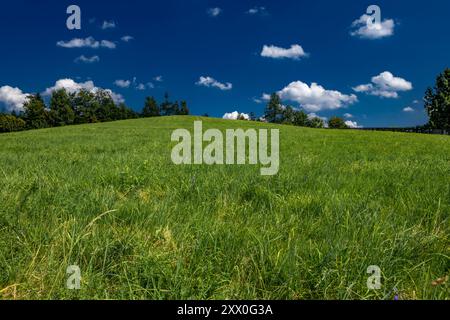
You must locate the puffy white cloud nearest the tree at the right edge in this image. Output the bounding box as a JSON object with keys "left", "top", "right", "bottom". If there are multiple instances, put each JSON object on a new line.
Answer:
{"left": 353, "top": 71, "right": 413, "bottom": 98}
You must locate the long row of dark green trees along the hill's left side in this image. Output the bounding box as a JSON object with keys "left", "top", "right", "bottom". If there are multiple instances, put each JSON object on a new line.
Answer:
{"left": 0, "top": 89, "right": 189, "bottom": 132}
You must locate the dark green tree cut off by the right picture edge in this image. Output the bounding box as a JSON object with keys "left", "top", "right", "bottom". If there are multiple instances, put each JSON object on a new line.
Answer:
{"left": 424, "top": 68, "right": 450, "bottom": 130}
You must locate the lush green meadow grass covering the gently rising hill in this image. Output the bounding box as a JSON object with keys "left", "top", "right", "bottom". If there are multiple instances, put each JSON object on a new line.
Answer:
{"left": 0, "top": 117, "right": 450, "bottom": 299}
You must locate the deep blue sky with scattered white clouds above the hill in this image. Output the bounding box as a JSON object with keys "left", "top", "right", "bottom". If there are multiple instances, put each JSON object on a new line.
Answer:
{"left": 0, "top": 0, "right": 450, "bottom": 127}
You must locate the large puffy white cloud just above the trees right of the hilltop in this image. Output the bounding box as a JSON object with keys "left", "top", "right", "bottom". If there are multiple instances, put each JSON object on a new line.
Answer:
{"left": 278, "top": 81, "right": 358, "bottom": 112}
